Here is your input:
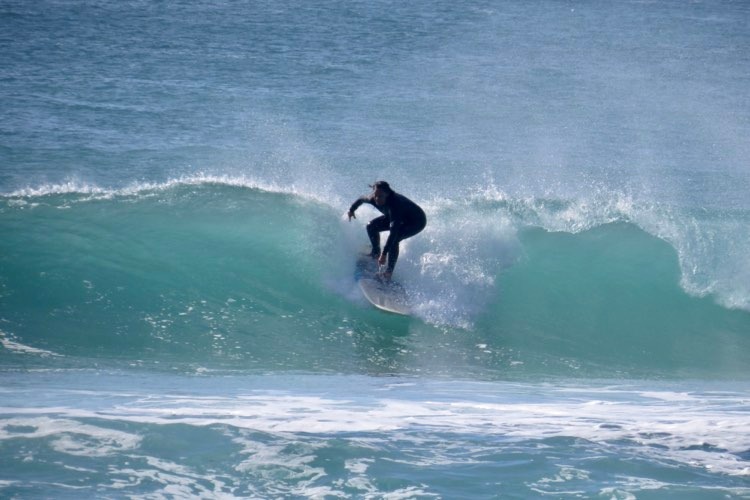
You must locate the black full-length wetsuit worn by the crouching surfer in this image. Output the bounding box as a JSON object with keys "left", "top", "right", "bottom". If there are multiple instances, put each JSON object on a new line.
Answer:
{"left": 349, "top": 191, "right": 427, "bottom": 273}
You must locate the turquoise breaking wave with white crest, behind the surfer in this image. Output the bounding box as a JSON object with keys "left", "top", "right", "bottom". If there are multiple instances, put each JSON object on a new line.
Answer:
{"left": 0, "top": 178, "right": 750, "bottom": 378}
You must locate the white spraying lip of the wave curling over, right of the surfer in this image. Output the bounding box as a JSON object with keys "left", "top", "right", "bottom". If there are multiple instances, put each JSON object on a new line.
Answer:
{"left": 462, "top": 183, "right": 750, "bottom": 312}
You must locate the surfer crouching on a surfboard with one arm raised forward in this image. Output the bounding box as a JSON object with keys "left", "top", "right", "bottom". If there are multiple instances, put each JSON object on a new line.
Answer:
{"left": 347, "top": 181, "right": 427, "bottom": 280}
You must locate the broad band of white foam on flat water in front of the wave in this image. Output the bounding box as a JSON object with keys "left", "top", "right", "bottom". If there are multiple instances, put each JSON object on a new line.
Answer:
{"left": 0, "top": 373, "right": 750, "bottom": 476}
